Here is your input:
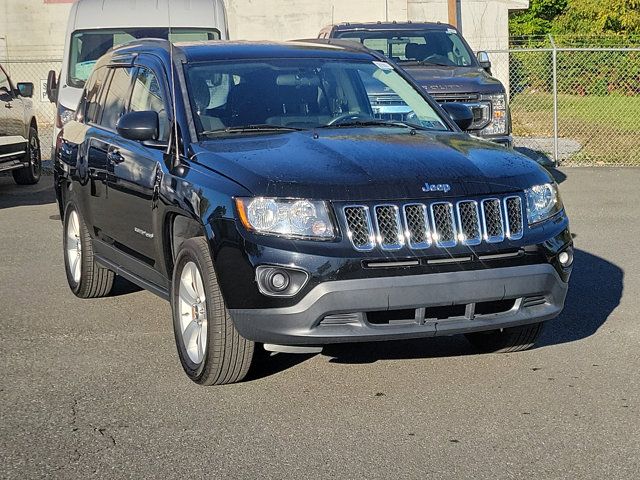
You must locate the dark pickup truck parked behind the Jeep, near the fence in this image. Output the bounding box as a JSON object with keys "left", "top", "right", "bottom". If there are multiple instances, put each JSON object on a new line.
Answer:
{"left": 319, "top": 22, "right": 512, "bottom": 146}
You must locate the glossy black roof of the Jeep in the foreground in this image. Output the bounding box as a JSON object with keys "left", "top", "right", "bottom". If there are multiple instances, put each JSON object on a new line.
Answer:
{"left": 111, "top": 40, "right": 379, "bottom": 62}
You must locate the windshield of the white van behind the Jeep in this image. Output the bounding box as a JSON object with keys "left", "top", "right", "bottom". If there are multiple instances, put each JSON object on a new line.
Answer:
{"left": 67, "top": 28, "right": 220, "bottom": 88}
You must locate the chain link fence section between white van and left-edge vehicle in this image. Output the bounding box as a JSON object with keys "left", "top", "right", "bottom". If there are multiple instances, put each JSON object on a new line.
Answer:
{"left": 2, "top": 59, "right": 62, "bottom": 162}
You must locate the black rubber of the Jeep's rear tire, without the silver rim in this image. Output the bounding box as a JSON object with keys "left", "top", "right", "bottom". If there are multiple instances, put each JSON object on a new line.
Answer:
{"left": 63, "top": 204, "right": 115, "bottom": 298}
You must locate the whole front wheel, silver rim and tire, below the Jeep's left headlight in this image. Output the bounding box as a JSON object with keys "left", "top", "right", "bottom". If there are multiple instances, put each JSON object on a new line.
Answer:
{"left": 171, "top": 237, "right": 255, "bottom": 385}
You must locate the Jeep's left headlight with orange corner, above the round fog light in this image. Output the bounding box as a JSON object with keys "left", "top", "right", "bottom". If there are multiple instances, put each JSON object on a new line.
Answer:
{"left": 236, "top": 197, "right": 335, "bottom": 240}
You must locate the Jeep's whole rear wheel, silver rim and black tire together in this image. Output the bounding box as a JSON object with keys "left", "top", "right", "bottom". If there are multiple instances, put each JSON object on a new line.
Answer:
{"left": 63, "top": 205, "right": 115, "bottom": 298}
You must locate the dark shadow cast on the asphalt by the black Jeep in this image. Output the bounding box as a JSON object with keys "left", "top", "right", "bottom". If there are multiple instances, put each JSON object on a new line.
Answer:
{"left": 244, "top": 250, "right": 624, "bottom": 380}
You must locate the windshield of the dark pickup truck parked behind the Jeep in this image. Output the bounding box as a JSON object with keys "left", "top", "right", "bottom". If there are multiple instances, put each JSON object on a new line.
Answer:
{"left": 338, "top": 28, "right": 477, "bottom": 67}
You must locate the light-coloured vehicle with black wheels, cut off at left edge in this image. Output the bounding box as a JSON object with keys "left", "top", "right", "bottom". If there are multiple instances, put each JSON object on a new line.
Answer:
{"left": 0, "top": 65, "right": 42, "bottom": 185}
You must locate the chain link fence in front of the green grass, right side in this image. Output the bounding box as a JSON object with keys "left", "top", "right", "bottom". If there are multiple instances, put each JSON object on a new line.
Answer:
{"left": 492, "top": 37, "right": 640, "bottom": 166}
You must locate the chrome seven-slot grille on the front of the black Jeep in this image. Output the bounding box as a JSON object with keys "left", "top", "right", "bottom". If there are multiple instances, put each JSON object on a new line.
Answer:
{"left": 343, "top": 196, "right": 524, "bottom": 251}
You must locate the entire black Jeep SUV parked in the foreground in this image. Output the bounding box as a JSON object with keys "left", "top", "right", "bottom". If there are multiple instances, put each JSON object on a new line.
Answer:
{"left": 55, "top": 40, "right": 573, "bottom": 384}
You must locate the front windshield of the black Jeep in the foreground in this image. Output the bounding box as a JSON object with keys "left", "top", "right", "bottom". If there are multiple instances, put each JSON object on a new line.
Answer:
{"left": 186, "top": 59, "right": 448, "bottom": 136}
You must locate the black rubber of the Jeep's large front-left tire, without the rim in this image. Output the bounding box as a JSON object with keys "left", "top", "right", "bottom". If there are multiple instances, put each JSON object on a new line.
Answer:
{"left": 171, "top": 237, "right": 255, "bottom": 385}
